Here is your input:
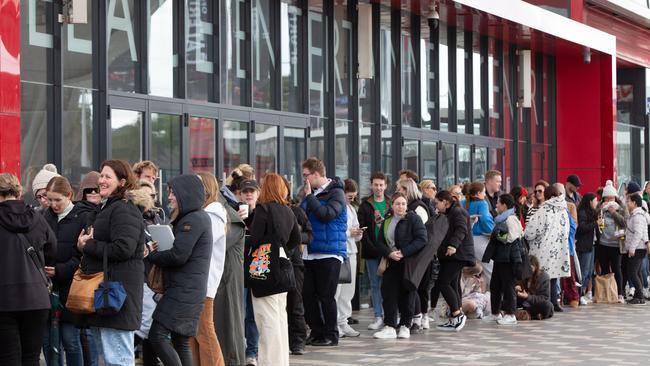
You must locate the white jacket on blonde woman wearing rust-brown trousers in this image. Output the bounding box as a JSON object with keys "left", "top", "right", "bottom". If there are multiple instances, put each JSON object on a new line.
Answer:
{"left": 204, "top": 202, "right": 228, "bottom": 299}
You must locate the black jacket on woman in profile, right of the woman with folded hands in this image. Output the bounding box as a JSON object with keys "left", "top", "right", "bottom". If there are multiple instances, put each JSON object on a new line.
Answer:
{"left": 438, "top": 202, "right": 476, "bottom": 266}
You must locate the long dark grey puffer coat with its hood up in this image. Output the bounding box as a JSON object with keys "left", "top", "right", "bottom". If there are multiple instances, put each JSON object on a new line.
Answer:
{"left": 147, "top": 174, "right": 212, "bottom": 336}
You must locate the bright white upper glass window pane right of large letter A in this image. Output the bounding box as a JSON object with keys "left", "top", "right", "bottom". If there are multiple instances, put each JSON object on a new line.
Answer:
{"left": 147, "top": 0, "right": 177, "bottom": 97}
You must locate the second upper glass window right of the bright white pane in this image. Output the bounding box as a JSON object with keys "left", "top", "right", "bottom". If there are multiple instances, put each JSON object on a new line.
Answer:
{"left": 220, "top": 0, "right": 250, "bottom": 106}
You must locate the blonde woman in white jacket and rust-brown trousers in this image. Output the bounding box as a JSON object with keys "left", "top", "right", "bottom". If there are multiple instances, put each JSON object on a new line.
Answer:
{"left": 190, "top": 173, "right": 228, "bottom": 366}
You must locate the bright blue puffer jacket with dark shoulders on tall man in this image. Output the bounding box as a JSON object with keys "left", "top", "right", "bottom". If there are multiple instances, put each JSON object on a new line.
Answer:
{"left": 301, "top": 177, "right": 348, "bottom": 258}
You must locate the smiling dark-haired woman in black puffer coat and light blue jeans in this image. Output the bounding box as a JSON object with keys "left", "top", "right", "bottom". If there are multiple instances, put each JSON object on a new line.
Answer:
{"left": 77, "top": 160, "right": 144, "bottom": 365}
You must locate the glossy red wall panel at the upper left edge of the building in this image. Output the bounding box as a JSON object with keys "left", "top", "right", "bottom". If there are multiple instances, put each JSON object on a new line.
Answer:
{"left": 0, "top": 0, "right": 20, "bottom": 176}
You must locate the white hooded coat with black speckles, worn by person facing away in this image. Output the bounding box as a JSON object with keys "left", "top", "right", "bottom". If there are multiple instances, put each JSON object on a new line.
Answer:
{"left": 524, "top": 196, "right": 571, "bottom": 278}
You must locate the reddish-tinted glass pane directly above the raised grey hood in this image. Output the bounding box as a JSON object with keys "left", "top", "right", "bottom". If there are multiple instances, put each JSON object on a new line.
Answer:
{"left": 189, "top": 117, "right": 217, "bottom": 174}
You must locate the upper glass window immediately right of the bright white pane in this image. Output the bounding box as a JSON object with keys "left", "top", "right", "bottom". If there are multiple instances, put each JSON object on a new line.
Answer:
{"left": 185, "top": 0, "right": 218, "bottom": 102}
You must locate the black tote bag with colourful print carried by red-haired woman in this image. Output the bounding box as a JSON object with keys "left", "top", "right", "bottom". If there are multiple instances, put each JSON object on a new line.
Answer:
{"left": 244, "top": 205, "right": 296, "bottom": 297}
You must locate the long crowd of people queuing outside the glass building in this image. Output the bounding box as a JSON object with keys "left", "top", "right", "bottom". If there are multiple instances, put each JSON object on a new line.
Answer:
{"left": 0, "top": 158, "right": 650, "bottom": 366}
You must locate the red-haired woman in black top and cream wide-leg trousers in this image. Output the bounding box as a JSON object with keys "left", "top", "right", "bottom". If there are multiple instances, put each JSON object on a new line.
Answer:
{"left": 246, "top": 173, "right": 300, "bottom": 366}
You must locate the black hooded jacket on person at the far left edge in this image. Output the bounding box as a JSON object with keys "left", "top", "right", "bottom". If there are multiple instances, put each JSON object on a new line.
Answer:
{"left": 0, "top": 200, "right": 56, "bottom": 312}
